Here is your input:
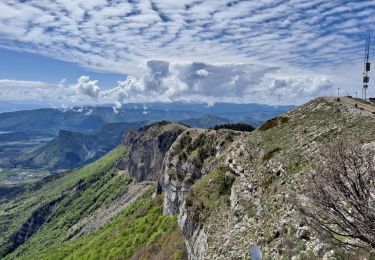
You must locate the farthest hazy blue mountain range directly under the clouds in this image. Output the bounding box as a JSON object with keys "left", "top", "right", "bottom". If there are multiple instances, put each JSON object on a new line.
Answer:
{"left": 0, "top": 102, "right": 293, "bottom": 134}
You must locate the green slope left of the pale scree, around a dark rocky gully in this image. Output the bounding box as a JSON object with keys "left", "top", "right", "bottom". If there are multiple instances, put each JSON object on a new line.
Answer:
{"left": 0, "top": 146, "right": 131, "bottom": 256}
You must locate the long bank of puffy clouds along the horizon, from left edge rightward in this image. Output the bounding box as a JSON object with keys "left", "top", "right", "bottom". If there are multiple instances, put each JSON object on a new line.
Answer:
{"left": 0, "top": 60, "right": 333, "bottom": 107}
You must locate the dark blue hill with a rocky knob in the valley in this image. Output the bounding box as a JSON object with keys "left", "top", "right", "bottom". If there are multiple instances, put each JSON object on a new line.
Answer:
{"left": 12, "top": 122, "right": 145, "bottom": 171}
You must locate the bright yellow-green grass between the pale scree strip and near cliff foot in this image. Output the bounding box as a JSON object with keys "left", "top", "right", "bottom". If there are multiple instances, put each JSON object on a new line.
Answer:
{"left": 9, "top": 189, "right": 186, "bottom": 260}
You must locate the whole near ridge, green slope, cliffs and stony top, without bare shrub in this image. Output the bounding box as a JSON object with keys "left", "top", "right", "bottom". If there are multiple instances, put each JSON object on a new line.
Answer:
{"left": 0, "top": 97, "right": 375, "bottom": 259}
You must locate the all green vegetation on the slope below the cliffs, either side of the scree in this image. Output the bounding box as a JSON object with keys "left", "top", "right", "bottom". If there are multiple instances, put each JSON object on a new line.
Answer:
{"left": 0, "top": 146, "right": 186, "bottom": 259}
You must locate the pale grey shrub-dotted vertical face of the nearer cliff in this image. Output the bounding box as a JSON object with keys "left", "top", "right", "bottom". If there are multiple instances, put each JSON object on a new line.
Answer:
{"left": 160, "top": 129, "right": 246, "bottom": 259}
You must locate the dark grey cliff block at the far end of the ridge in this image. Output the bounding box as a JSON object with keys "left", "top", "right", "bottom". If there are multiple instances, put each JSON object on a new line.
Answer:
{"left": 122, "top": 121, "right": 187, "bottom": 182}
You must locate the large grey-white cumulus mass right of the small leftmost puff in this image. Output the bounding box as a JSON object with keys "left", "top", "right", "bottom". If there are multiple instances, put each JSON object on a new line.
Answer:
{"left": 92, "top": 60, "right": 333, "bottom": 105}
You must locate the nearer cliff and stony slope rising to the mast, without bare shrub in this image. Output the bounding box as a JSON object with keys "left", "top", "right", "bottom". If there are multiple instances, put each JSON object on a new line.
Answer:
{"left": 159, "top": 98, "right": 375, "bottom": 259}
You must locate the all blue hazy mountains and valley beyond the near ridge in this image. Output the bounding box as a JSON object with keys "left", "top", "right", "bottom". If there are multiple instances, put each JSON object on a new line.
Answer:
{"left": 0, "top": 102, "right": 293, "bottom": 178}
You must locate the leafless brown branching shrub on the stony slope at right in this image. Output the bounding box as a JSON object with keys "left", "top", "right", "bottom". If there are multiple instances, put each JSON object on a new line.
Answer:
{"left": 296, "top": 140, "right": 375, "bottom": 252}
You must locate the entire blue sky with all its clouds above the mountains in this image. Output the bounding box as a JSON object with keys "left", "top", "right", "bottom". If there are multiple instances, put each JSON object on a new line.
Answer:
{"left": 0, "top": 0, "right": 375, "bottom": 108}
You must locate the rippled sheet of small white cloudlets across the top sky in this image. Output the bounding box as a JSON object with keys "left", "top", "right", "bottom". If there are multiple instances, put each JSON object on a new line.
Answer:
{"left": 0, "top": 0, "right": 375, "bottom": 75}
